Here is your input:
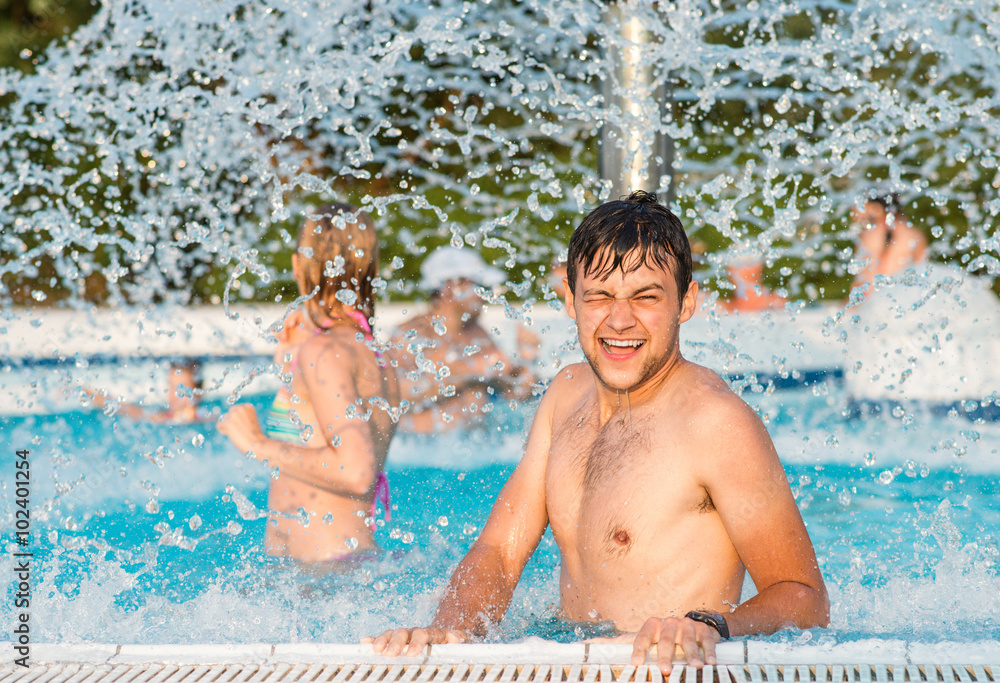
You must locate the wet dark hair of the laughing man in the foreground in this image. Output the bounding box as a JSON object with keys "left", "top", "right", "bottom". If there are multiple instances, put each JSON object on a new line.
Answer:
{"left": 566, "top": 190, "right": 692, "bottom": 299}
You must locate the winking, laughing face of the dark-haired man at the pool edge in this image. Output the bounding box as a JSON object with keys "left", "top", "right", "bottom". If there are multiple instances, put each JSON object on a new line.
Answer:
{"left": 566, "top": 251, "right": 698, "bottom": 391}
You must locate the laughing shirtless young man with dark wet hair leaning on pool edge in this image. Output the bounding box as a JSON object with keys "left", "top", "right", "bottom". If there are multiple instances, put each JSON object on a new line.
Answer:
{"left": 373, "top": 192, "right": 829, "bottom": 673}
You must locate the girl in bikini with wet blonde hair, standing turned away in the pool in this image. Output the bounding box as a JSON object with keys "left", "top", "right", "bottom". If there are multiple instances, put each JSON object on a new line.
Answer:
{"left": 219, "top": 204, "right": 400, "bottom": 562}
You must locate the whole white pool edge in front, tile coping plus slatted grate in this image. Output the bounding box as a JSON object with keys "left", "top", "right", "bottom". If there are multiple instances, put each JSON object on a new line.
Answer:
{"left": 0, "top": 639, "right": 1000, "bottom": 683}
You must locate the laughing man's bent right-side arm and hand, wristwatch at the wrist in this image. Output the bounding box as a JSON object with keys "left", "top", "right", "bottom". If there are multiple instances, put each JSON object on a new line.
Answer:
{"left": 632, "top": 395, "right": 830, "bottom": 674}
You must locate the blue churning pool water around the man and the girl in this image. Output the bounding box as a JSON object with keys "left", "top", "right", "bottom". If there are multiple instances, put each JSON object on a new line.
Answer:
{"left": 0, "top": 381, "right": 1000, "bottom": 643}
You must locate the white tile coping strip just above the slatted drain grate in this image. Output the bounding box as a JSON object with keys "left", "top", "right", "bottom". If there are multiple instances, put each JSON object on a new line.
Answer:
{"left": 0, "top": 638, "right": 1000, "bottom": 668}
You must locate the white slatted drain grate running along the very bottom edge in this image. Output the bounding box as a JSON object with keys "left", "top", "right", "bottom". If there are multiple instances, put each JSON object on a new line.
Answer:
{"left": 0, "top": 663, "right": 1000, "bottom": 683}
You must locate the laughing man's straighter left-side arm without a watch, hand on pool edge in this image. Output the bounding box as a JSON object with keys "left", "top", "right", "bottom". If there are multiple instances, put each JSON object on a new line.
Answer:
{"left": 362, "top": 374, "right": 559, "bottom": 656}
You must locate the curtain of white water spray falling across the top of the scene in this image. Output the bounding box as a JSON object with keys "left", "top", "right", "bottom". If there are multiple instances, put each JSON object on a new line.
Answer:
{"left": 0, "top": 0, "right": 1000, "bottom": 310}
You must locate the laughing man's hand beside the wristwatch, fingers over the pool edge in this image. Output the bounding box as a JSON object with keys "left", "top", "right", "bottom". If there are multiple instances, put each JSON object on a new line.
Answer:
{"left": 586, "top": 617, "right": 721, "bottom": 675}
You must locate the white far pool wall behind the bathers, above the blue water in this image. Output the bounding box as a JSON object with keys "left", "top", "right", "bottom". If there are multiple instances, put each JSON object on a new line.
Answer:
{"left": 0, "top": 304, "right": 844, "bottom": 415}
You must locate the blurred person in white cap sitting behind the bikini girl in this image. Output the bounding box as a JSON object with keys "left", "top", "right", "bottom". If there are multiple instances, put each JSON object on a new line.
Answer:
{"left": 391, "top": 246, "right": 534, "bottom": 433}
